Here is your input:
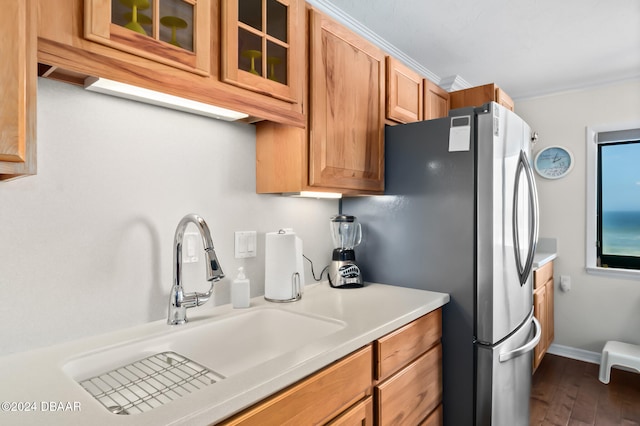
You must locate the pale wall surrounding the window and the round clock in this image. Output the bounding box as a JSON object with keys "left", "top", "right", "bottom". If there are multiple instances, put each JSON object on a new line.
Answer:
{"left": 516, "top": 80, "right": 640, "bottom": 352}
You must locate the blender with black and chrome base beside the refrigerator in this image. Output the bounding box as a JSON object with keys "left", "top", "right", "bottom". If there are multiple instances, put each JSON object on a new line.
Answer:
{"left": 329, "top": 214, "right": 363, "bottom": 288}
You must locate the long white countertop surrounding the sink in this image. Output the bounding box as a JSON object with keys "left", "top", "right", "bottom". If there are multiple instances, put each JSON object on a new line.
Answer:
{"left": 0, "top": 283, "right": 449, "bottom": 426}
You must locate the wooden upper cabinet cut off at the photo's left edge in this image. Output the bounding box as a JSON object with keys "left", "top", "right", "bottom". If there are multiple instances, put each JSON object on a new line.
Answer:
{"left": 0, "top": 0, "right": 37, "bottom": 180}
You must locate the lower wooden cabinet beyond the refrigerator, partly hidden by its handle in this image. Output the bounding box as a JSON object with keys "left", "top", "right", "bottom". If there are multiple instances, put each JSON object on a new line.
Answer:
{"left": 533, "top": 261, "right": 555, "bottom": 371}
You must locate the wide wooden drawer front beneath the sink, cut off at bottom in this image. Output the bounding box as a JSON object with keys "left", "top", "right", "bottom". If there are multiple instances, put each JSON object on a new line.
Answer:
{"left": 222, "top": 346, "right": 373, "bottom": 426}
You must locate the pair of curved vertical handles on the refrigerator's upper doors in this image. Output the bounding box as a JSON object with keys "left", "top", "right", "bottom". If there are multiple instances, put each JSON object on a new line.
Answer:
{"left": 511, "top": 150, "right": 538, "bottom": 285}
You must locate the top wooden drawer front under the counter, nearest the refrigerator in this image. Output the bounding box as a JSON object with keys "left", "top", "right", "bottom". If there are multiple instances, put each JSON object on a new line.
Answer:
{"left": 374, "top": 309, "right": 442, "bottom": 381}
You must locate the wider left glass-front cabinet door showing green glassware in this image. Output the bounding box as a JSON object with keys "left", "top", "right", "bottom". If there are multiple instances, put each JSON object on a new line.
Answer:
{"left": 85, "top": 0, "right": 214, "bottom": 75}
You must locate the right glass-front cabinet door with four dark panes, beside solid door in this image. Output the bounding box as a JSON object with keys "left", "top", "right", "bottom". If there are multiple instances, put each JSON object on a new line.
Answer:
{"left": 222, "top": 0, "right": 304, "bottom": 103}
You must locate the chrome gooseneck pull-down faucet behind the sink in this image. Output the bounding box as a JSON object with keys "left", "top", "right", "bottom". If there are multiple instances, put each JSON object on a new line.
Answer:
{"left": 167, "top": 214, "right": 224, "bottom": 325}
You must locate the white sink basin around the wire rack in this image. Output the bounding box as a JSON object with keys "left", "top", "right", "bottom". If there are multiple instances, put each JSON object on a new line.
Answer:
{"left": 63, "top": 307, "right": 345, "bottom": 414}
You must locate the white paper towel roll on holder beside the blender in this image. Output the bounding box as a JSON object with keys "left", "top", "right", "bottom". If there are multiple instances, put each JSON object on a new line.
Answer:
{"left": 264, "top": 229, "right": 304, "bottom": 302}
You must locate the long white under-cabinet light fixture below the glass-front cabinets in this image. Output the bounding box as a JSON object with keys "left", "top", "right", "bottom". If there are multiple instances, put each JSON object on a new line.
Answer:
{"left": 84, "top": 77, "right": 248, "bottom": 121}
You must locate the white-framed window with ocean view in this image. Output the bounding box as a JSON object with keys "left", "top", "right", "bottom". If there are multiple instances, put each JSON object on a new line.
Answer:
{"left": 587, "top": 127, "right": 640, "bottom": 278}
